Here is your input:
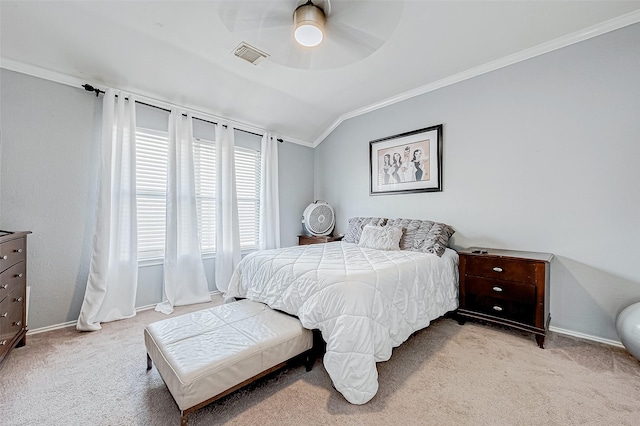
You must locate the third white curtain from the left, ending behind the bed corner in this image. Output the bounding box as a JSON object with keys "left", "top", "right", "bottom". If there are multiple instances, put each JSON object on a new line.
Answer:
{"left": 216, "top": 124, "right": 240, "bottom": 293}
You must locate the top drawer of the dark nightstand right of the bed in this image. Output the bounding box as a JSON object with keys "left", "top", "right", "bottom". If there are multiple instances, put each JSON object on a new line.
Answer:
{"left": 465, "top": 256, "right": 536, "bottom": 284}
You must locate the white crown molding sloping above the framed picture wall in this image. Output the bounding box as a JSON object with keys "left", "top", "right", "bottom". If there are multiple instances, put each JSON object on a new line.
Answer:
{"left": 313, "top": 9, "right": 640, "bottom": 148}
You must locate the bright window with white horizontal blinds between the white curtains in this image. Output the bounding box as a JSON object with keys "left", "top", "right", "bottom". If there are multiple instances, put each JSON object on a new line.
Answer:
{"left": 136, "top": 127, "right": 260, "bottom": 260}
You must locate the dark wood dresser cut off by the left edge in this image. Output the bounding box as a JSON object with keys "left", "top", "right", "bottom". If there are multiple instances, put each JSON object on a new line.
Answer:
{"left": 0, "top": 231, "right": 30, "bottom": 364}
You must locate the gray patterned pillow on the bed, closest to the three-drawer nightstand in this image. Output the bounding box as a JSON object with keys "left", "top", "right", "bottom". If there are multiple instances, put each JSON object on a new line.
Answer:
{"left": 387, "top": 219, "right": 455, "bottom": 256}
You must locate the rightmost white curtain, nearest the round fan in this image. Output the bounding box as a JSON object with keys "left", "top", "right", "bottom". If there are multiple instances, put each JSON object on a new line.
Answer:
{"left": 259, "top": 133, "right": 280, "bottom": 250}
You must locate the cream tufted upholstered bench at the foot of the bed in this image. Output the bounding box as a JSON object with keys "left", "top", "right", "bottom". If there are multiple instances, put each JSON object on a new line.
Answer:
{"left": 144, "top": 300, "right": 315, "bottom": 425}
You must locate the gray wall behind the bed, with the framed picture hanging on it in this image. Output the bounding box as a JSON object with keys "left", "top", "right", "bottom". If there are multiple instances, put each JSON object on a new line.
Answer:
{"left": 315, "top": 24, "right": 640, "bottom": 341}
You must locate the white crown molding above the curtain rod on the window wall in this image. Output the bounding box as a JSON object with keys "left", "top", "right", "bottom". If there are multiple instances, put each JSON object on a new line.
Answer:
{"left": 0, "top": 56, "right": 313, "bottom": 147}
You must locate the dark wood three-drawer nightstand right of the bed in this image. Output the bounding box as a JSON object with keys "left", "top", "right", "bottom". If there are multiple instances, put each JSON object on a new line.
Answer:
{"left": 457, "top": 247, "right": 553, "bottom": 348}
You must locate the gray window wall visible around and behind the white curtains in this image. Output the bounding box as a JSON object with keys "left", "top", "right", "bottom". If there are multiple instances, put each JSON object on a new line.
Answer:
{"left": 0, "top": 69, "right": 313, "bottom": 329}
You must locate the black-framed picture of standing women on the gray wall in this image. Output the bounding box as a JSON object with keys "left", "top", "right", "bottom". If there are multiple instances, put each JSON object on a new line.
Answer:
{"left": 369, "top": 124, "right": 442, "bottom": 195}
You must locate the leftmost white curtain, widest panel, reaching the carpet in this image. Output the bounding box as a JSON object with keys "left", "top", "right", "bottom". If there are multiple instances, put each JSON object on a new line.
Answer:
{"left": 76, "top": 89, "right": 138, "bottom": 331}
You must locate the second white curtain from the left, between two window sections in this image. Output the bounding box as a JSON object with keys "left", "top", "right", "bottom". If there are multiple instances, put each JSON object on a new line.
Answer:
{"left": 156, "top": 109, "right": 211, "bottom": 314}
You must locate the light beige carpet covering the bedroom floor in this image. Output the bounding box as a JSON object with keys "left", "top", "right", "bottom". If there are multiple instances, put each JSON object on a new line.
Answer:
{"left": 0, "top": 297, "right": 640, "bottom": 426}
